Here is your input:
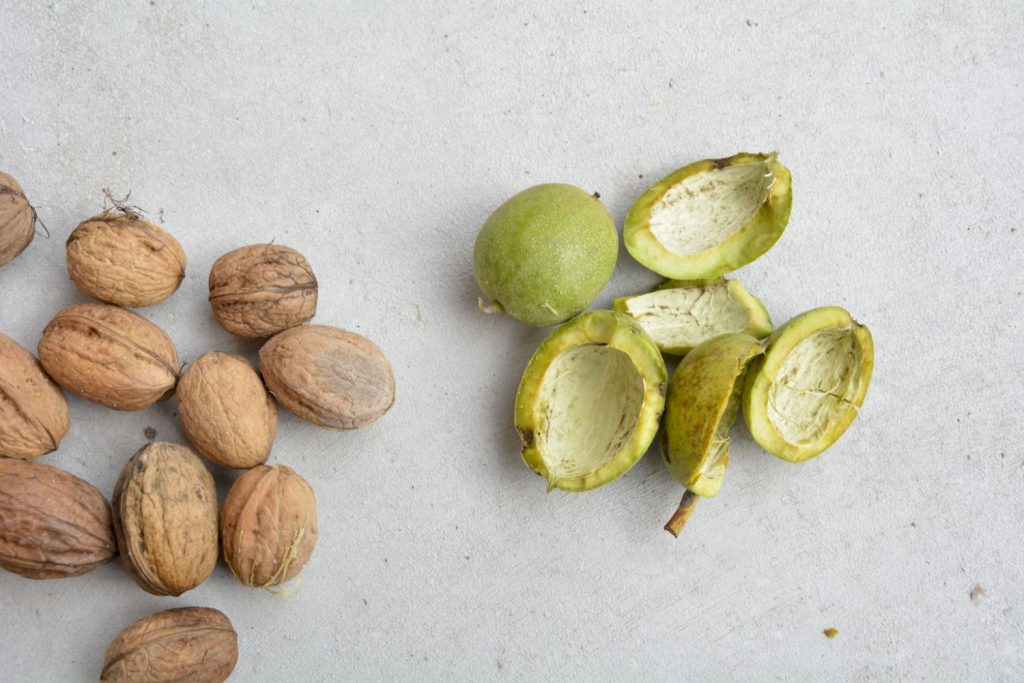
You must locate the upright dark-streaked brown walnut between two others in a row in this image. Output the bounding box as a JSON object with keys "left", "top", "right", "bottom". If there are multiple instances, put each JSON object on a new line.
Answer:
{"left": 113, "top": 441, "right": 218, "bottom": 596}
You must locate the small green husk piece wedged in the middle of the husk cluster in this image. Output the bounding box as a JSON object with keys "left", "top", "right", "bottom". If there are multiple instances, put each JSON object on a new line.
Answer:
{"left": 612, "top": 278, "right": 772, "bottom": 355}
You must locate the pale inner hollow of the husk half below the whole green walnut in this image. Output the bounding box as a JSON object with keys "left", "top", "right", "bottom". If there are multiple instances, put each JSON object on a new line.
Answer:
{"left": 538, "top": 344, "right": 644, "bottom": 479}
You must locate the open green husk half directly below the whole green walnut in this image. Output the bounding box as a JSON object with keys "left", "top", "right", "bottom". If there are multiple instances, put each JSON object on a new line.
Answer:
{"left": 515, "top": 310, "right": 668, "bottom": 492}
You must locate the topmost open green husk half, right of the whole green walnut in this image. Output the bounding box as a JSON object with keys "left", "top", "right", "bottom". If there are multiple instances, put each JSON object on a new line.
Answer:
{"left": 624, "top": 154, "right": 793, "bottom": 280}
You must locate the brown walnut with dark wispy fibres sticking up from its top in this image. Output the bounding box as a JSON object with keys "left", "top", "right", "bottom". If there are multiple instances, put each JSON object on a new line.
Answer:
{"left": 68, "top": 211, "right": 186, "bottom": 306}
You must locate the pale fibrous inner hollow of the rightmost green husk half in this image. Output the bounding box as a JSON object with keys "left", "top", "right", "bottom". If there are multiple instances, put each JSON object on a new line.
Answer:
{"left": 768, "top": 328, "right": 861, "bottom": 444}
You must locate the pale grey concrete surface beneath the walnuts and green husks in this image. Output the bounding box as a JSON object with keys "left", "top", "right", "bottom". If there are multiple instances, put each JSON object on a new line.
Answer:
{"left": 0, "top": 0, "right": 1024, "bottom": 681}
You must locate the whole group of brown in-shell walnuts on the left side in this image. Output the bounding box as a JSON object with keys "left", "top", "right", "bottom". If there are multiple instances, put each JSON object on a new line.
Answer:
{"left": 0, "top": 173, "right": 394, "bottom": 681}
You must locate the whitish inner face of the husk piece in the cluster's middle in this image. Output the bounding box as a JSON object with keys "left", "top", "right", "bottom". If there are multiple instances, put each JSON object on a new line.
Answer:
{"left": 626, "top": 283, "right": 751, "bottom": 348}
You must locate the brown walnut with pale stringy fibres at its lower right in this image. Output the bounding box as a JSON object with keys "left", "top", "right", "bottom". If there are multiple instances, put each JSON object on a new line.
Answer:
{"left": 220, "top": 465, "right": 319, "bottom": 589}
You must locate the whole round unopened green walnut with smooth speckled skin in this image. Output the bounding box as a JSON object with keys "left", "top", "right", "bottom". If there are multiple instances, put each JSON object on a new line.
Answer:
{"left": 473, "top": 184, "right": 618, "bottom": 326}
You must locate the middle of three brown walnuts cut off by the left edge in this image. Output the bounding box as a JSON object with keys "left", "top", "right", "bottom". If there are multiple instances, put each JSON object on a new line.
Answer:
{"left": 0, "top": 334, "right": 69, "bottom": 460}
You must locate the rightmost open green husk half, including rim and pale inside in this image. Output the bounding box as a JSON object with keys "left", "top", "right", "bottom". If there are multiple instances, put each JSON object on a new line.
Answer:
{"left": 743, "top": 306, "right": 874, "bottom": 463}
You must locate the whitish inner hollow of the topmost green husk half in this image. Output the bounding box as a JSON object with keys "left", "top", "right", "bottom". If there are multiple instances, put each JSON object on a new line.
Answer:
{"left": 650, "top": 163, "right": 774, "bottom": 256}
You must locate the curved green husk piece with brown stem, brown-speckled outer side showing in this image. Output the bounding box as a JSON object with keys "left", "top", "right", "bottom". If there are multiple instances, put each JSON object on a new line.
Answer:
{"left": 662, "top": 333, "right": 765, "bottom": 537}
